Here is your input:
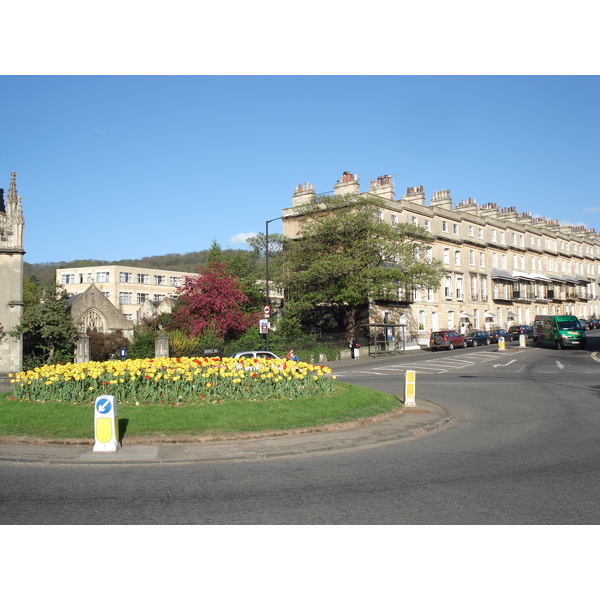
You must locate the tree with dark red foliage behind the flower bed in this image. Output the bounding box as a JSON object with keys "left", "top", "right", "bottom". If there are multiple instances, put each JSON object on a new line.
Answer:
{"left": 170, "top": 262, "right": 259, "bottom": 340}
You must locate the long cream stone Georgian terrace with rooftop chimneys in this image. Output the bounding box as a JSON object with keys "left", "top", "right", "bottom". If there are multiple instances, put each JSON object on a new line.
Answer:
{"left": 282, "top": 172, "right": 600, "bottom": 346}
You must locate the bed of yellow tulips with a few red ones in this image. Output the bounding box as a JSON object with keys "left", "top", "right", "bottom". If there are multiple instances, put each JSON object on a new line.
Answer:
{"left": 11, "top": 357, "right": 335, "bottom": 404}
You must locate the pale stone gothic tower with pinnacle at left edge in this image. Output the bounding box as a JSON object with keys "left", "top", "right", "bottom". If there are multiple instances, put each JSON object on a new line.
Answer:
{"left": 0, "top": 171, "right": 25, "bottom": 389}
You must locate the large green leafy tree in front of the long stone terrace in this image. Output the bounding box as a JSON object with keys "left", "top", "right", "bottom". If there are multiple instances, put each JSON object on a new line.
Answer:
{"left": 284, "top": 195, "right": 444, "bottom": 335}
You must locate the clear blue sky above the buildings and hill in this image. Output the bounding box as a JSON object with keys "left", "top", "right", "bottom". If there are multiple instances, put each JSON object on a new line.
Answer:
{"left": 0, "top": 75, "right": 600, "bottom": 263}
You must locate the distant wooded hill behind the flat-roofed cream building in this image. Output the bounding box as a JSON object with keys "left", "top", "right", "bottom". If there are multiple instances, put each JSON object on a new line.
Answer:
{"left": 23, "top": 249, "right": 262, "bottom": 285}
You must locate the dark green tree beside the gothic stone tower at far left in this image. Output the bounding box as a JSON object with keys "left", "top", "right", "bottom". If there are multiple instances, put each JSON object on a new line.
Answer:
{"left": 10, "top": 281, "right": 77, "bottom": 364}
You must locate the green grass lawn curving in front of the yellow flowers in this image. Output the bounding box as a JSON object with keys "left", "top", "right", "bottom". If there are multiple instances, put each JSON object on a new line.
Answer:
{"left": 0, "top": 382, "right": 400, "bottom": 439}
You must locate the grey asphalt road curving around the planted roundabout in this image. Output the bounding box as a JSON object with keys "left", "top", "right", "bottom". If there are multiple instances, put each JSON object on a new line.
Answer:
{"left": 0, "top": 331, "right": 600, "bottom": 525}
